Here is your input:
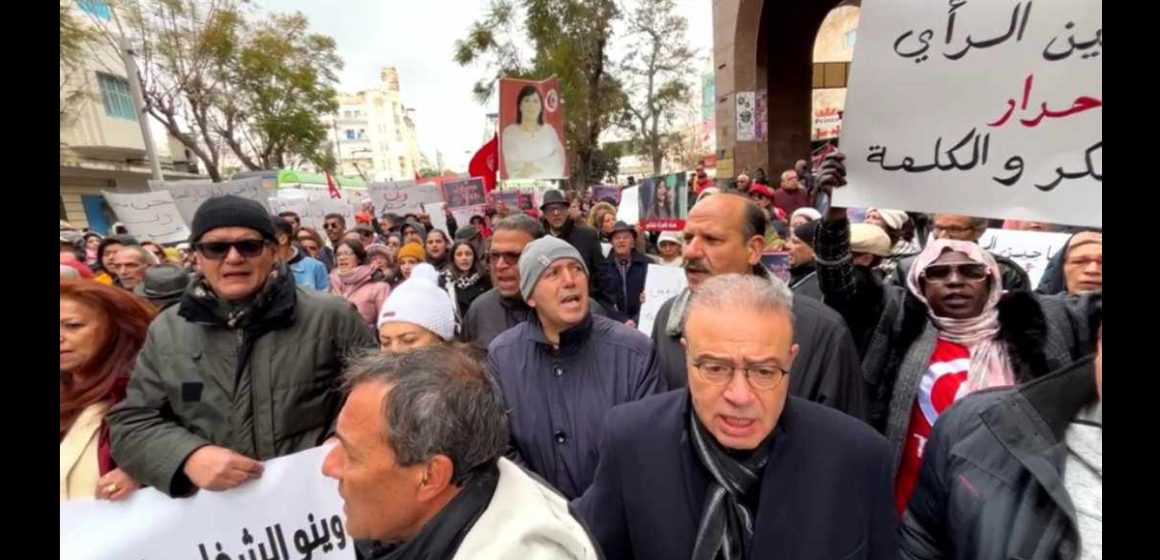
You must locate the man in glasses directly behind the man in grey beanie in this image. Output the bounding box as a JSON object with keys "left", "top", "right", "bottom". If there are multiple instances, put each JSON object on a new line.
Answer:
{"left": 459, "top": 212, "right": 607, "bottom": 348}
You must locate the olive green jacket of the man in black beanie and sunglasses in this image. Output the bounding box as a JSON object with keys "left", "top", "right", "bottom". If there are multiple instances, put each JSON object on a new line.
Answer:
{"left": 107, "top": 264, "right": 377, "bottom": 496}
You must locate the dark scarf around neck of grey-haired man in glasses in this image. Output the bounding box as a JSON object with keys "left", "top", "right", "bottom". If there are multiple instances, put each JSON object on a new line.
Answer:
{"left": 689, "top": 405, "right": 773, "bottom": 560}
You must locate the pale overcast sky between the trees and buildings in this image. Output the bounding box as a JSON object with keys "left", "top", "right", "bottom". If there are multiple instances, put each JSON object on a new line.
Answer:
{"left": 260, "top": 0, "right": 712, "bottom": 170}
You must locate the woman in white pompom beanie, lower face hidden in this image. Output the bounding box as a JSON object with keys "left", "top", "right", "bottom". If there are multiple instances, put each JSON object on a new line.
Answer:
{"left": 378, "top": 263, "right": 456, "bottom": 352}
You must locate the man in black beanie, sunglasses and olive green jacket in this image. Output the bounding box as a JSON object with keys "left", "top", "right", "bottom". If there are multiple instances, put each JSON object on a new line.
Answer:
{"left": 108, "top": 196, "right": 376, "bottom": 496}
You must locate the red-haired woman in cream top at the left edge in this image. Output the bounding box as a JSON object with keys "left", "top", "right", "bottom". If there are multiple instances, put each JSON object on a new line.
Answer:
{"left": 60, "top": 279, "right": 153, "bottom": 502}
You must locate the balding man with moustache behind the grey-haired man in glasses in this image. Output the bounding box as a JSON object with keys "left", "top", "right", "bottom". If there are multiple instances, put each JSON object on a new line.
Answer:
{"left": 653, "top": 194, "right": 870, "bottom": 420}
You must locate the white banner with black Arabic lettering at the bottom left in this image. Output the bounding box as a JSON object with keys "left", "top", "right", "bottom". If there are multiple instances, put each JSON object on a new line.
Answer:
{"left": 60, "top": 446, "right": 355, "bottom": 560}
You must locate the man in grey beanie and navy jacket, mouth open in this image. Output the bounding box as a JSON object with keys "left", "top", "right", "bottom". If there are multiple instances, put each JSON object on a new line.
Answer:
{"left": 488, "top": 237, "right": 664, "bottom": 500}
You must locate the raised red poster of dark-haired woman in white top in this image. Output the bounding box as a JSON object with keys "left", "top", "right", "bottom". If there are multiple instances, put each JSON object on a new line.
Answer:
{"left": 499, "top": 78, "right": 568, "bottom": 181}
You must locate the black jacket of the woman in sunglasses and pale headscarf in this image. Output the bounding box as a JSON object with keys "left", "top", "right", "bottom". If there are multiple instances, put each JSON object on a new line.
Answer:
{"left": 814, "top": 219, "right": 1102, "bottom": 468}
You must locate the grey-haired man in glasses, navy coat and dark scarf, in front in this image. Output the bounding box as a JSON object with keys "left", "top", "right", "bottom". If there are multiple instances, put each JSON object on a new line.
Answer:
{"left": 575, "top": 274, "right": 898, "bottom": 560}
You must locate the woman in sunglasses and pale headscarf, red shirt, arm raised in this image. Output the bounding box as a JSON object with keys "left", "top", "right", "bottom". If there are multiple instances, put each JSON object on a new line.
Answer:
{"left": 814, "top": 157, "right": 1099, "bottom": 512}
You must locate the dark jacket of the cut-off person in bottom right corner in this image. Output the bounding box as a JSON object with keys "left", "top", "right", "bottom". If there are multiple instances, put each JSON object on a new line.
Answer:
{"left": 899, "top": 356, "right": 1097, "bottom": 560}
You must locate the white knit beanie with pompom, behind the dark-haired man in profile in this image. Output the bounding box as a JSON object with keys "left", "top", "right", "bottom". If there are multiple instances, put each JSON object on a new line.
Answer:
{"left": 378, "top": 263, "right": 455, "bottom": 341}
